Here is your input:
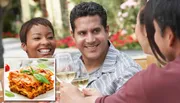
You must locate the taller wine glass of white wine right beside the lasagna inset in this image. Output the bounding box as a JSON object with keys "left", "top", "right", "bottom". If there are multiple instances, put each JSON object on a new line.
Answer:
{"left": 55, "top": 53, "right": 76, "bottom": 83}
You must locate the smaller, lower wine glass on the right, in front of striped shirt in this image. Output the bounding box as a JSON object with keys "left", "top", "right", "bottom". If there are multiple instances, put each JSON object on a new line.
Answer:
{"left": 71, "top": 66, "right": 89, "bottom": 91}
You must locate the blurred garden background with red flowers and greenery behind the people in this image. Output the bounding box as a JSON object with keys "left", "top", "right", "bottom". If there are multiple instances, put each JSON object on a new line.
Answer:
{"left": 0, "top": 0, "right": 141, "bottom": 65}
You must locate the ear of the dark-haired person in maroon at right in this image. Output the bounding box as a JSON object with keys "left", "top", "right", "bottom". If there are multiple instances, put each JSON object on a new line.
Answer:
{"left": 164, "top": 27, "right": 175, "bottom": 47}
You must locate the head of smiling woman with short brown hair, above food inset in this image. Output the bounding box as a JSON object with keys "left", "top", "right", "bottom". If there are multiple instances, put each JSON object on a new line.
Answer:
{"left": 20, "top": 18, "right": 56, "bottom": 58}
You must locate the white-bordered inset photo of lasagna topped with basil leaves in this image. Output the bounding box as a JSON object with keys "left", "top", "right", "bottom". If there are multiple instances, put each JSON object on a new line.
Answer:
{"left": 4, "top": 58, "right": 55, "bottom": 101}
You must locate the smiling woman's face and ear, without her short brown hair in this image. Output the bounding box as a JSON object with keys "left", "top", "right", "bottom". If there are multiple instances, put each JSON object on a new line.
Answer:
{"left": 21, "top": 24, "right": 56, "bottom": 58}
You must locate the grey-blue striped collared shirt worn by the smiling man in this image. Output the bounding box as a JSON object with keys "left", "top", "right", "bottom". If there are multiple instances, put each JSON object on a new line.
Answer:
{"left": 73, "top": 43, "right": 141, "bottom": 95}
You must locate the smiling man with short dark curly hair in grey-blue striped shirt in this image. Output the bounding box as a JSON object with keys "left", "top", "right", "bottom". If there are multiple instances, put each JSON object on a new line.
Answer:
{"left": 59, "top": 2, "right": 141, "bottom": 95}
